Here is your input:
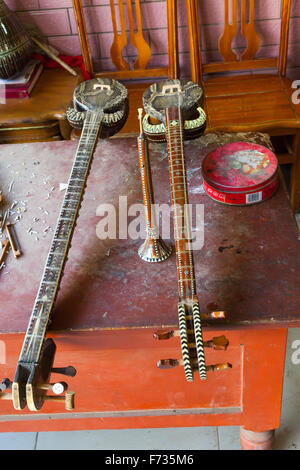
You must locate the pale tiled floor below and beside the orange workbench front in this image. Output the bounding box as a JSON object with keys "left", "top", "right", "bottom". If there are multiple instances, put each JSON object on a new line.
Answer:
{"left": 0, "top": 218, "right": 300, "bottom": 450}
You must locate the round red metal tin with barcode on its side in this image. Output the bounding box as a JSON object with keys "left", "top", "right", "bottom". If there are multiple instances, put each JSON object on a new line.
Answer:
{"left": 202, "top": 142, "right": 279, "bottom": 205}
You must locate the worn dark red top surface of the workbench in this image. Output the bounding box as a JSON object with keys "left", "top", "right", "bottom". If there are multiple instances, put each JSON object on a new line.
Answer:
{"left": 0, "top": 135, "right": 300, "bottom": 333}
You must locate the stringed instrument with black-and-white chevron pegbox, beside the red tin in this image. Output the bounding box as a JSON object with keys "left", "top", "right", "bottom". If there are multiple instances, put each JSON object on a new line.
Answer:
{"left": 140, "top": 79, "right": 230, "bottom": 382}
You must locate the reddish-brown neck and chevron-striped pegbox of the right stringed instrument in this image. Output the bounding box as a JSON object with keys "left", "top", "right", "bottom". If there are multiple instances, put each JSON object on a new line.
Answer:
{"left": 165, "top": 105, "right": 206, "bottom": 381}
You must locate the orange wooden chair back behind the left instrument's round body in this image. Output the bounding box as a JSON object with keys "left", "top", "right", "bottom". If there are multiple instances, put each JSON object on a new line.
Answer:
{"left": 73, "top": 0, "right": 178, "bottom": 79}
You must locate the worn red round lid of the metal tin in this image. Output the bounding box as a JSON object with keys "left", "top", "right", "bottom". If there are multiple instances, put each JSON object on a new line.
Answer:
{"left": 202, "top": 142, "right": 278, "bottom": 192}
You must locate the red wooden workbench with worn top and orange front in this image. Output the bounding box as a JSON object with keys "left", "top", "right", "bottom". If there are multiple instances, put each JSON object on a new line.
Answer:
{"left": 0, "top": 135, "right": 300, "bottom": 448}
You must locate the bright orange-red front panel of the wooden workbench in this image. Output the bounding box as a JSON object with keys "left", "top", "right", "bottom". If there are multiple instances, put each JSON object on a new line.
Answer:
{"left": 0, "top": 328, "right": 286, "bottom": 442}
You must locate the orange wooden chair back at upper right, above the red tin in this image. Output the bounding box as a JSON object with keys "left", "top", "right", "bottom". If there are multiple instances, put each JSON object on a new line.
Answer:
{"left": 186, "top": 0, "right": 291, "bottom": 82}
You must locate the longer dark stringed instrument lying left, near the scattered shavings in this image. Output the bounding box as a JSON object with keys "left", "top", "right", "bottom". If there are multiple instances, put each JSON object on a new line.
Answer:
{"left": 0, "top": 78, "right": 128, "bottom": 411}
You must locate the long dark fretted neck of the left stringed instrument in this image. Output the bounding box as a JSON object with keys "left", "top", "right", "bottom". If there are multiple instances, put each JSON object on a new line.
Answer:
{"left": 19, "top": 111, "right": 103, "bottom": 363}
